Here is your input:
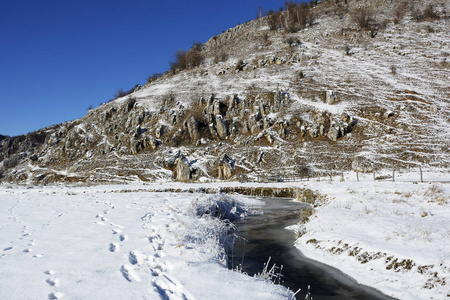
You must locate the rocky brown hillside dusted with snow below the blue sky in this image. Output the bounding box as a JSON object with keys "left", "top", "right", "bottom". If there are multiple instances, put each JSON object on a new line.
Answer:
{"left": 0, "top": 0, "right": 450, "bottom": 183}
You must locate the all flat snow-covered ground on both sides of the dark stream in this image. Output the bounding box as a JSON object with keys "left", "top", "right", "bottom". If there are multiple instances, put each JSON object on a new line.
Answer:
{"left": 0, "top": 172, "right": 450, "bottom": 299}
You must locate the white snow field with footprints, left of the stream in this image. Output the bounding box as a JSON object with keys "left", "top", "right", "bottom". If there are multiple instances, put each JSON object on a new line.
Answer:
{"left": 0, "top": 186, "right": 293, "bottom": 299}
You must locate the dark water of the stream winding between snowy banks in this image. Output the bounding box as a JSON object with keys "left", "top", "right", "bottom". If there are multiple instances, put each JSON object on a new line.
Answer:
{"left": 230, "top": 198, "right": 393, "bottom": 300}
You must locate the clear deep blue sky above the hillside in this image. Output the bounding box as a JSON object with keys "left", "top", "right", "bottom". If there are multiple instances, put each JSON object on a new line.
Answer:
{"left": 0, "top": 0, "right": 308, "bottom": 136}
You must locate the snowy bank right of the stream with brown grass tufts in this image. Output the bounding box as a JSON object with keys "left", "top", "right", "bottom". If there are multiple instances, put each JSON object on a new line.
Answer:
{"left": 294, "top": 174, "right": 450, "bottom": 300}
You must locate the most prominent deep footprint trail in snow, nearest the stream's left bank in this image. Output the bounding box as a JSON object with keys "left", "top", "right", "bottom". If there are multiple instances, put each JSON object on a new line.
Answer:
{"left": 96, "top": 201, "right": 193, "bottom": 300}
